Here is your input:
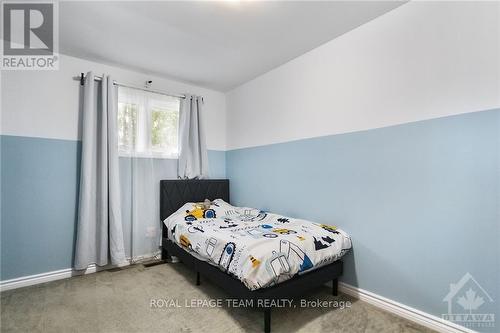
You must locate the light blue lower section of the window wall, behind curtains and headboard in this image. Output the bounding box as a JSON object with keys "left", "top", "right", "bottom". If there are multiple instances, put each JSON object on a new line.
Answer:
{"left": 0, "top": 135, "right": 225, "bottom": 280}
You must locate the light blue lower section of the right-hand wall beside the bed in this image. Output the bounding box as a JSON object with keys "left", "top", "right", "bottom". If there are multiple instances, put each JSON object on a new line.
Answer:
{"left": 226, "top": 110, "right": 500, "bottom": 324}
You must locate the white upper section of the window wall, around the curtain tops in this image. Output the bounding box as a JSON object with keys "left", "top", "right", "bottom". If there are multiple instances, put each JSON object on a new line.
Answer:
{"left": 0, "top": 55, "right": 226, "bottom": 150}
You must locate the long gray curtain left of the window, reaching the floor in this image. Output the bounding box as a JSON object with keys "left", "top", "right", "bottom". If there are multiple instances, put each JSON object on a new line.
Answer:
{"left": 75, "top": 72, "right": 126, "bottom": 269}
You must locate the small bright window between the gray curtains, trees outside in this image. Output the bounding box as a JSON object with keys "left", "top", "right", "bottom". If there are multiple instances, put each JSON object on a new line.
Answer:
{"left": 118, "top": 87, "right": 180, "bottom": 158}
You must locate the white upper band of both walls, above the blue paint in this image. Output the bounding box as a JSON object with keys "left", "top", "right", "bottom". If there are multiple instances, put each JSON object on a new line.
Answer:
{"left": 0, "top": 2, "right": 500, "bottom": 150}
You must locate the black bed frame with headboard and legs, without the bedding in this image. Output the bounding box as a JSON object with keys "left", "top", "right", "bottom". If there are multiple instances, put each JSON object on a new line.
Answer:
{"left": 160, "top": 179, "right": 342, "bottom": 333}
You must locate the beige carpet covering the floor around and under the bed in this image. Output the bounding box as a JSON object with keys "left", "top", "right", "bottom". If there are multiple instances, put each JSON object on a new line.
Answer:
{"left": 0, "top": 263, "right": 430, "bottom": 333}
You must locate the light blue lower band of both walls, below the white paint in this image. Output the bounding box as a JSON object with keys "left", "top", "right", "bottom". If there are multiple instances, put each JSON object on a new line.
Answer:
{"left": 0, "top": 110, "right": 500, "bottom": 326}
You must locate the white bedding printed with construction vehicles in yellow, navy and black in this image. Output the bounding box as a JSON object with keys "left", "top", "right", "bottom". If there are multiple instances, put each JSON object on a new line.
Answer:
{"left": 164, "top": 199, "right": 351, "bottom": 290}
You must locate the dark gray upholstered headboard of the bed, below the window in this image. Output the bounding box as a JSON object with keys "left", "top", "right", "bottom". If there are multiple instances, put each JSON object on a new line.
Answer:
{"left": 160, "top": 179, "right": 229, "bottom": 225}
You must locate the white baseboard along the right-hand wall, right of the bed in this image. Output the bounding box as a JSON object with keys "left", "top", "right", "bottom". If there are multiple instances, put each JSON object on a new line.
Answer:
{"left": 339, "top": 282, "right": 476, "bottom": 333}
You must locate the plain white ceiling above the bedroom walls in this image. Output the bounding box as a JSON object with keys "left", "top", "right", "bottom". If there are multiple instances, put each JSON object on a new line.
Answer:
{"left": 59, "top": 1, "right": 404, "bottom": 91}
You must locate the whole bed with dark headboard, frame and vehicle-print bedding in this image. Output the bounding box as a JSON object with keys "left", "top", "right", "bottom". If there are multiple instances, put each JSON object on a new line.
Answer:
{"left": 160, "top": 179, "right": 350, "bottom": 332}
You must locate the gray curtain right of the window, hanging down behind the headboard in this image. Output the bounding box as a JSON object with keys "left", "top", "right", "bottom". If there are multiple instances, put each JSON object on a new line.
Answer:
{"left": 178, "top": 95, "right": 208, "bottom": 178}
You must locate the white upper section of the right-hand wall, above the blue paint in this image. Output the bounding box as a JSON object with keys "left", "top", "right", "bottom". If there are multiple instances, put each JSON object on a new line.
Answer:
{"left": 226, "top": 2, "right": 500, "bottom": 149}
